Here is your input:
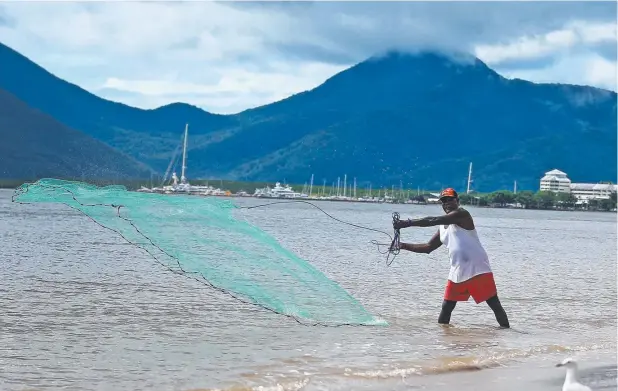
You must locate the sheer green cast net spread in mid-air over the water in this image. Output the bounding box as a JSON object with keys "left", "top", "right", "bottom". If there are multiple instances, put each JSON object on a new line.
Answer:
{"left": 13, "top": 179, "right": 386, "bottom": 326}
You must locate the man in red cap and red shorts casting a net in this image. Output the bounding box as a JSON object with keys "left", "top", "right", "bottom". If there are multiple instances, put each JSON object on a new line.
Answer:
{"left": 393, "top": 188, "right": 509, "bottom": 328}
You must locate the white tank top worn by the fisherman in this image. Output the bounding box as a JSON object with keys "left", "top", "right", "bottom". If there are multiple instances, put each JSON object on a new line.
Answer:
{"left": 440, "top": 224, "right": 491, "bottom": 283}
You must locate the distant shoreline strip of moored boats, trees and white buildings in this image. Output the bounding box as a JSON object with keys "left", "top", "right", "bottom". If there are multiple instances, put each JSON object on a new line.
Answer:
{"left": 137, "top": 124, "right": 618, "bottom": 212}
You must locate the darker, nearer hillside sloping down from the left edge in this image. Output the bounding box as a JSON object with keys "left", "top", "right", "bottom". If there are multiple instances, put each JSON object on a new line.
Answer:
{"left": 0, "top": 89, "right": 149, "bottom": 181}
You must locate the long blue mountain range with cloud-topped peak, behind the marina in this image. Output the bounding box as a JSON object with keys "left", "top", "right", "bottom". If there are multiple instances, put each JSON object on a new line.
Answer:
{"left": 0, "top": 45, "right": 617, "bottom": 191}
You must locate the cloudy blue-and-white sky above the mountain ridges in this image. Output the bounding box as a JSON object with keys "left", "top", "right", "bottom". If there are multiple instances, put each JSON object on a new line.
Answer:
{"left": 0, "top": 0, "right": 617, "bottom": 113}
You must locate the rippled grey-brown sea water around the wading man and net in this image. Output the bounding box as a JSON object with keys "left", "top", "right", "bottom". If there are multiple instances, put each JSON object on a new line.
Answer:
{"left": 0, "top": 190, "right": 617, "bottom": 391}
